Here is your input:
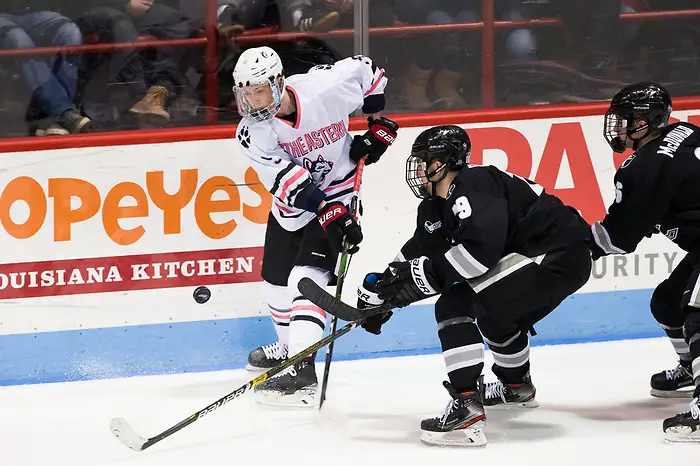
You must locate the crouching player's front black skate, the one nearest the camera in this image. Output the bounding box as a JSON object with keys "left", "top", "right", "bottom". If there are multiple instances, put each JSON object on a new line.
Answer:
{"left": 420, "top": 379, "right": 486, "bottom": 447}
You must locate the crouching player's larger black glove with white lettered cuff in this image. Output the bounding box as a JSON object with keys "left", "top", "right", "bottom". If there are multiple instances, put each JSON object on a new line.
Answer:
{"left": 377, "top": 256, "right": 440, "bottom": 307}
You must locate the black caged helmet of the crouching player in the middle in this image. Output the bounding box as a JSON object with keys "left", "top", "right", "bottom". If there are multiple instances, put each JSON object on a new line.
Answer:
{"left": 406, "top": 125, "right": 472, "bottom": 199}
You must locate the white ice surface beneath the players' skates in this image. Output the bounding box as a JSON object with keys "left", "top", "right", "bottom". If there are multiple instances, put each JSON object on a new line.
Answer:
{"left": 0, "top": 339, "right": 700, "bottom": 466}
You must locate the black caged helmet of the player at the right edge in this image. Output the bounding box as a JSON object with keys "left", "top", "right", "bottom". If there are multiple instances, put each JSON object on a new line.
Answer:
{"left": 603, "top": 82, "right": 673, "bottom": 152}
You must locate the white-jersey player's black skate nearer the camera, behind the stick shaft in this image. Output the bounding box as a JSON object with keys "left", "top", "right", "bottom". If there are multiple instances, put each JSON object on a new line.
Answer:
{"left": 255, "top": 356, "right": 318, "bottom": 408}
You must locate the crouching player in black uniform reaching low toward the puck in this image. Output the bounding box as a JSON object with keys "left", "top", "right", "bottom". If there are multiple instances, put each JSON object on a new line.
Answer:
{"left": 358, "top": 126, "right": 591, "bottom": 446}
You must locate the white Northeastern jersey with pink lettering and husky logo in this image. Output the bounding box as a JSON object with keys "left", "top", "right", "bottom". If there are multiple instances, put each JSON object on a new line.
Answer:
{"left": 236, "top": 56, "right": 387, "bottom": 231}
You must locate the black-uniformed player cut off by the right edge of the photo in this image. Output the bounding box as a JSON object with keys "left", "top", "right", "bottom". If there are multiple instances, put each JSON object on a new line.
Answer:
{"left": 591, "top": 82, "right": 700, "bottom": 442}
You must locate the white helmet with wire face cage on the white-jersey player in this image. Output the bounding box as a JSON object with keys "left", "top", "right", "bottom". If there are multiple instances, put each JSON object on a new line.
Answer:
{"left": 233, "top": 46, "right": 284, "bottom": 121}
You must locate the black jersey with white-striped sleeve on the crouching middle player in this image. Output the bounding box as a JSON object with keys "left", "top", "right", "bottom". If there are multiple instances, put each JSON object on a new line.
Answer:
{"left": 399, "top": 166, "right": 590, "bottom": 286}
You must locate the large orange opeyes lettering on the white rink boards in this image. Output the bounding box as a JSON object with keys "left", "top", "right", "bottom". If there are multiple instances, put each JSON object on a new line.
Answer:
{"left": 0, "top": 167, "right": 272, "bottom": 246}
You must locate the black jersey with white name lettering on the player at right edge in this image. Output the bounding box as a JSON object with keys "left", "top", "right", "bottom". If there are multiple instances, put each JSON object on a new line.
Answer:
{"left": 591, "top": 123, "right": 700, "bottom": 257}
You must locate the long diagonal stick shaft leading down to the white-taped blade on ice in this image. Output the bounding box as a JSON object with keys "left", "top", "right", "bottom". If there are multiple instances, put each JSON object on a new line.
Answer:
{"left": 114, "top": 304, "right": 380, "bottom": 451}
